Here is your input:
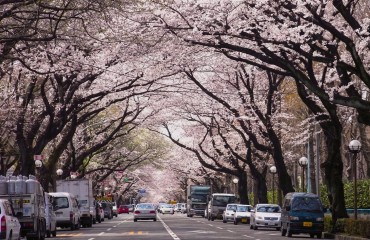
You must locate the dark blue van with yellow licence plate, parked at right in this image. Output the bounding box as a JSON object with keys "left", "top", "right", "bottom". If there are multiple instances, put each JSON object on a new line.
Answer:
{"left": 281, "top": 192, "right": 326, "bottom": 238}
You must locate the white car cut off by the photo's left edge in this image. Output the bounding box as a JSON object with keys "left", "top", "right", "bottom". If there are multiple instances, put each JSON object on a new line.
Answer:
{"left": 0, "top": 199, "right": 21, "bottom": 240}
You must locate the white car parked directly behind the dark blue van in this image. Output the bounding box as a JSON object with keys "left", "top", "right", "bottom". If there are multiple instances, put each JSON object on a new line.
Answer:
{"left": 250, "top": 204, "right": 281, "bottom": 231}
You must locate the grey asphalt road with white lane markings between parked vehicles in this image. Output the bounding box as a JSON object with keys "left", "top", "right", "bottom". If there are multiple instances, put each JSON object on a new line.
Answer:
{"left": 49, "top": 213, "right": 330, "bottom": 240}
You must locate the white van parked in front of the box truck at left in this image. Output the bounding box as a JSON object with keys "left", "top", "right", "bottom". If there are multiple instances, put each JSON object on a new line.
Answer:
{"left": 49, "top": 192, "right": 81, "bottom": 230}
